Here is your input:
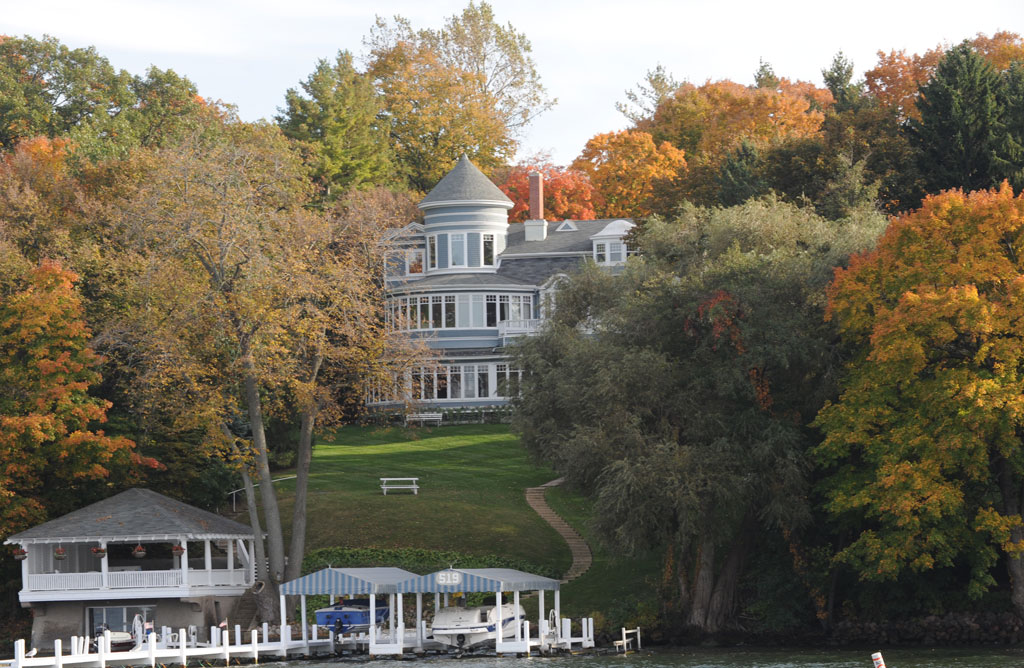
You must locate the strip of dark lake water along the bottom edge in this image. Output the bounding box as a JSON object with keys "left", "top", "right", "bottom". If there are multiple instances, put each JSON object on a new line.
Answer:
{"left": 260, "top": 648, "right": 1024, "bottom": 668}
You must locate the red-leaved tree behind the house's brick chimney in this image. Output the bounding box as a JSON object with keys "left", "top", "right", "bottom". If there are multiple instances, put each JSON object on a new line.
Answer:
{"left": 499, "top": 162, "right": 597, "bottom": 222}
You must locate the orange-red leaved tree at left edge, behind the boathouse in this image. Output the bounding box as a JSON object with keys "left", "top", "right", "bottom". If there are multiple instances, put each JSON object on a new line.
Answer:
{"left": 0, "top": 261, "right": 157, "bottom": 536}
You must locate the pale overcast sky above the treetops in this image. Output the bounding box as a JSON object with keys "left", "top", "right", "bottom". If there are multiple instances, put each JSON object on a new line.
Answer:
{"left": 0, "top": 0, "right": 1024, "bottom": 164}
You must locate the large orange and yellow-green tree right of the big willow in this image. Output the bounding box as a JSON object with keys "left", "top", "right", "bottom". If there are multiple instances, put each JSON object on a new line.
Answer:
{"left": 816, "top": 185, "right": 1024, "bottom": 614}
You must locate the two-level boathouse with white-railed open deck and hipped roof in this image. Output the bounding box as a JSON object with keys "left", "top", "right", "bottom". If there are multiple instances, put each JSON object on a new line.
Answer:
{"left": 4, "top": 489, "right": 255, "bottom": 648}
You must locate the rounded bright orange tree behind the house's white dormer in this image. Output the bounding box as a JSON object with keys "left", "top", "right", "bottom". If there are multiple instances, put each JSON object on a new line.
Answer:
{"left": 572, "top": 130, "right": 686, "bottom": 218}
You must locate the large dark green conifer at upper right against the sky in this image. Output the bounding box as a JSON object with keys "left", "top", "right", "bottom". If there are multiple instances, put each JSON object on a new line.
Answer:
{"left": 908, "top": 42, "right": 1021, "bottom": 193}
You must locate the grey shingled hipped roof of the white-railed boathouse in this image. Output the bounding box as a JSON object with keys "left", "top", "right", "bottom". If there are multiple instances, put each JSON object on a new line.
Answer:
{"left": 4, "top": 488, "right": 253, "bottom": 544}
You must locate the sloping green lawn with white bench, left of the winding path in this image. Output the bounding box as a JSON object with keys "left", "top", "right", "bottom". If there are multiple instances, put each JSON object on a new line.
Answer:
{"left": 278, "top": 424, "right": 571, "bottom": 572}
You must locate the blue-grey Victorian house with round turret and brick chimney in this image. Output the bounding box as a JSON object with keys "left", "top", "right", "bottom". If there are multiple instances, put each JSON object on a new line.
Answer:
{"left": 376, "top": 155, "right": 634, "bottom": 409}
